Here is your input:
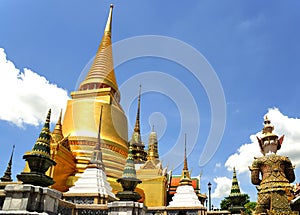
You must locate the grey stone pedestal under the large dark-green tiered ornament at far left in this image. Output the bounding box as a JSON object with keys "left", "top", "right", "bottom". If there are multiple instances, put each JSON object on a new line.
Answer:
{"left": 0, "top": 184, "right": 62, "bottom": 215}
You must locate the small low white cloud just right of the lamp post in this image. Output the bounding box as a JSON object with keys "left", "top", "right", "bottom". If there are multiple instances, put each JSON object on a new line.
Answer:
{"left": 211, "top": 177, "right": 232, "bottom": 198}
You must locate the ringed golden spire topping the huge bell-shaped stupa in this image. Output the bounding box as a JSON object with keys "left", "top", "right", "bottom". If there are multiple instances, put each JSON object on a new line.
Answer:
{"left": 79, "top": 4, "right": 118, "bottom": 96}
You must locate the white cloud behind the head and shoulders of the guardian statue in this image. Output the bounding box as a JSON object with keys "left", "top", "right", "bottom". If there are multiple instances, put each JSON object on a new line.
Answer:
{"left": 225, "top": 108, "right": 300, "bottom": 173}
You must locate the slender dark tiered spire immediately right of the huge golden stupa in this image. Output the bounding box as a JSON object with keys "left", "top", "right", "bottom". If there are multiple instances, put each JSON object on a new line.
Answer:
{"left": 130, "top": 85, "right": 147, "bottom": 164}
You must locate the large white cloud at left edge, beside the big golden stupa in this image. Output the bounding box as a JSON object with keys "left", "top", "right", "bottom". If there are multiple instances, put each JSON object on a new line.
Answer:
{"left": 0, "top": 48, "right": 69, "bottom": 127}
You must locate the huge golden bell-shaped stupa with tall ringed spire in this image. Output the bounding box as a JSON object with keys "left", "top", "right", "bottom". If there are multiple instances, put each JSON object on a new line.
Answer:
{"left": 62, "top": 5, "right": 128, "bottom": 186}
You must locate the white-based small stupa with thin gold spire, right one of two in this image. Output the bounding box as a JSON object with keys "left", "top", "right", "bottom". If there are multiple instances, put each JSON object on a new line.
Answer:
{"left": 168, "top": 135, "right": 203, "bottom": 208}
